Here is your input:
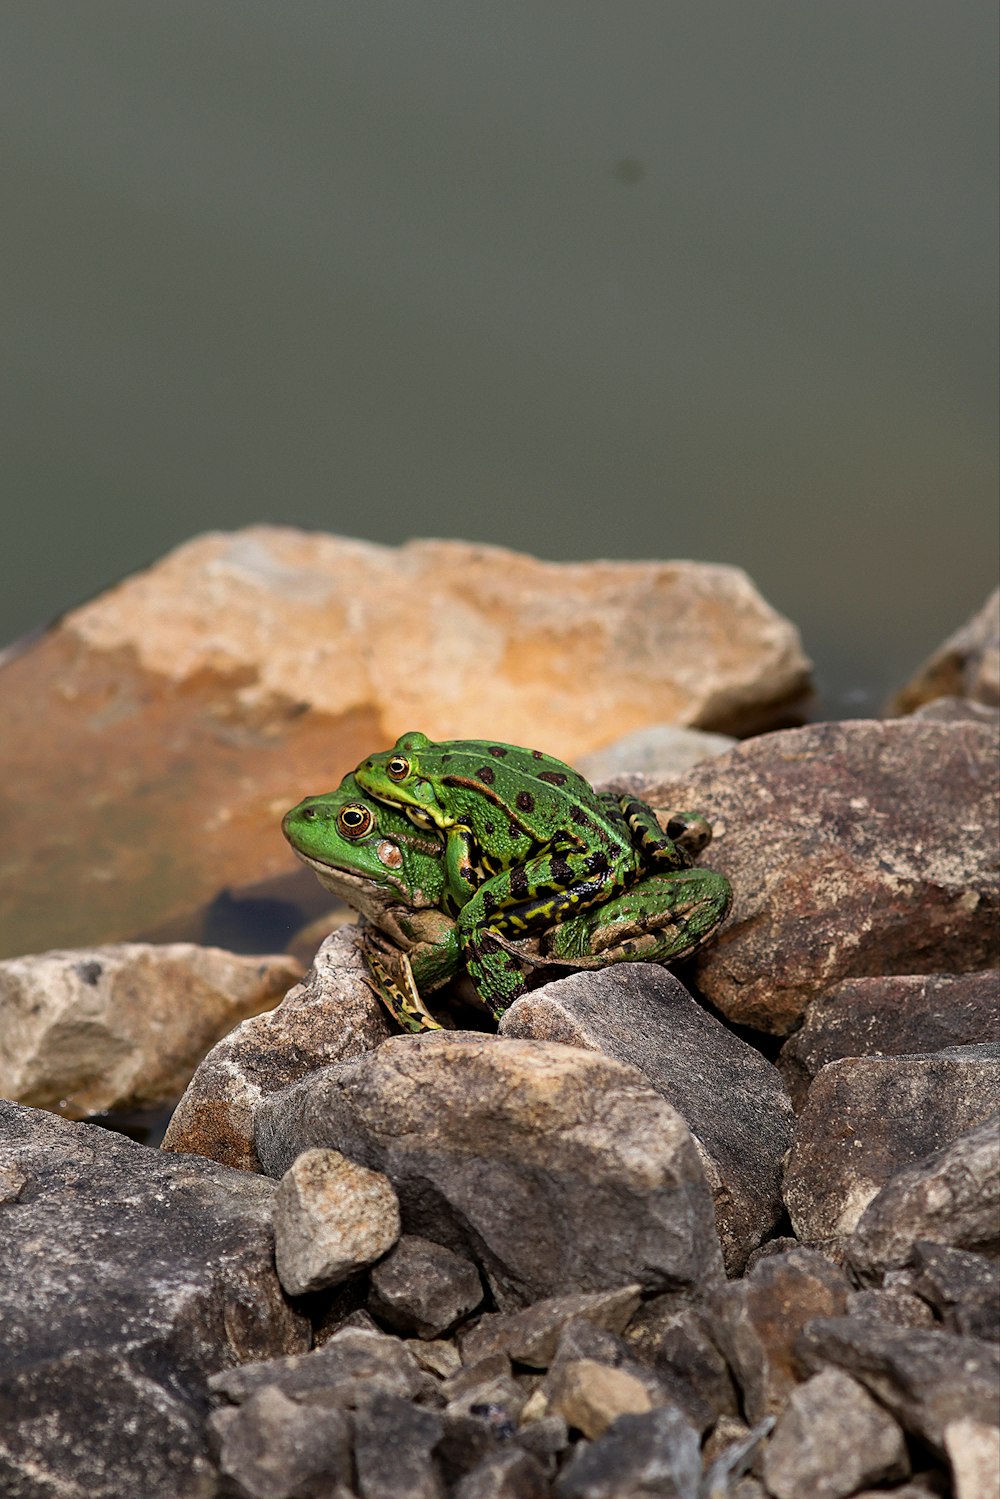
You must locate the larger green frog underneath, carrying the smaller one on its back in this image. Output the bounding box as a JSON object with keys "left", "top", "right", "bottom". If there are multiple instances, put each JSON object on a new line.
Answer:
{"left": 282, "top": 775, "right": 730, "bottom": 1031}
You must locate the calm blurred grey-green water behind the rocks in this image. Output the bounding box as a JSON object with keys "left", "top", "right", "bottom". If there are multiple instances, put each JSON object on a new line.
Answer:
{"left": 0, "top": 0, "right": 997, "bottom": 714}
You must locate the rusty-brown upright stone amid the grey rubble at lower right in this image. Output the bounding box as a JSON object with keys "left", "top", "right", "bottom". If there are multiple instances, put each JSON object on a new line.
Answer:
{"left": 709, "top": 1249, "right": 850, "bottom": 1423}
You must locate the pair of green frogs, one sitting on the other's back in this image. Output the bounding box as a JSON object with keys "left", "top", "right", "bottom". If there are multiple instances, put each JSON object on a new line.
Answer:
{"left": 282, "top": 733, "right": 732, "bottom": 1028}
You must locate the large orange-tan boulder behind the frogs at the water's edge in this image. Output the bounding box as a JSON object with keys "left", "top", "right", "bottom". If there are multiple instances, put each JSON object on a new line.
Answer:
{"left": 0, "top": 526, "right": 808, "bottom": 955}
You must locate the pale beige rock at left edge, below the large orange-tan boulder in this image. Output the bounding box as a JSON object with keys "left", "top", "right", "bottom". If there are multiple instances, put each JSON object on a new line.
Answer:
{"left": 0, "top": 943, "right": 301, "bottom": 1118}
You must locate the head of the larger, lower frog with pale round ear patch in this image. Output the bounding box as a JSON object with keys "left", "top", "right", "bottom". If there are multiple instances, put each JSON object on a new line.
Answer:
{"left": 282, "top": 775, "right": 444, "bottom": 914}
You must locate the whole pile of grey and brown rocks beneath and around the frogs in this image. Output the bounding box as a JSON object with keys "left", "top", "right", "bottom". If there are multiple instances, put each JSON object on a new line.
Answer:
{"left": 0, "top": 566, "right": 1000, "bottom": 1499}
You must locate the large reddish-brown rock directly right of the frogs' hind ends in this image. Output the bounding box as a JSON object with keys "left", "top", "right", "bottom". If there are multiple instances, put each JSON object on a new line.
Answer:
{"left": 602, "top": 718, "right": 1000, "bottom": 1034}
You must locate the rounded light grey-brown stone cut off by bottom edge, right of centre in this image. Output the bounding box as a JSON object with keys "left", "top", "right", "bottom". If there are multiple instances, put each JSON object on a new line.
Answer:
{"left": 763, "top": 1369, "right": 910, "bottom": 1499}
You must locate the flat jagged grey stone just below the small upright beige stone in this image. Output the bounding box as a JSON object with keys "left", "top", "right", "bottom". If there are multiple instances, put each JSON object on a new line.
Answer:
{"left": 208, "top": 1327, "right": 436, "bottom": 1409}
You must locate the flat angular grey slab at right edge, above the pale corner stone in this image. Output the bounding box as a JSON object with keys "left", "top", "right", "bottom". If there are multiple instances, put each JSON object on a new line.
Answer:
{"left": 796, "top": 1316, "right": 1000, "bottom": 1456}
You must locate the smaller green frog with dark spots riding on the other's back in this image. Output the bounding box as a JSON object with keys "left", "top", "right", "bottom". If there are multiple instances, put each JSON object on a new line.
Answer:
{"left": 347, "top": 732, "right": 729, "bottom": 1018}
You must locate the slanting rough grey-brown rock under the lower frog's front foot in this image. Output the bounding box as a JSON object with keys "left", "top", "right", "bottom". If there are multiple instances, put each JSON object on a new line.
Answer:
{"left": 163, "top": 925, "right": 391, "bottom": 1171}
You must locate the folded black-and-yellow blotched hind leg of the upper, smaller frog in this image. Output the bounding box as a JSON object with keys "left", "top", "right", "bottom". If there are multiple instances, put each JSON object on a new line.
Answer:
{"left": 457, "top": 848, "right": 636, "bottom": 1019}
